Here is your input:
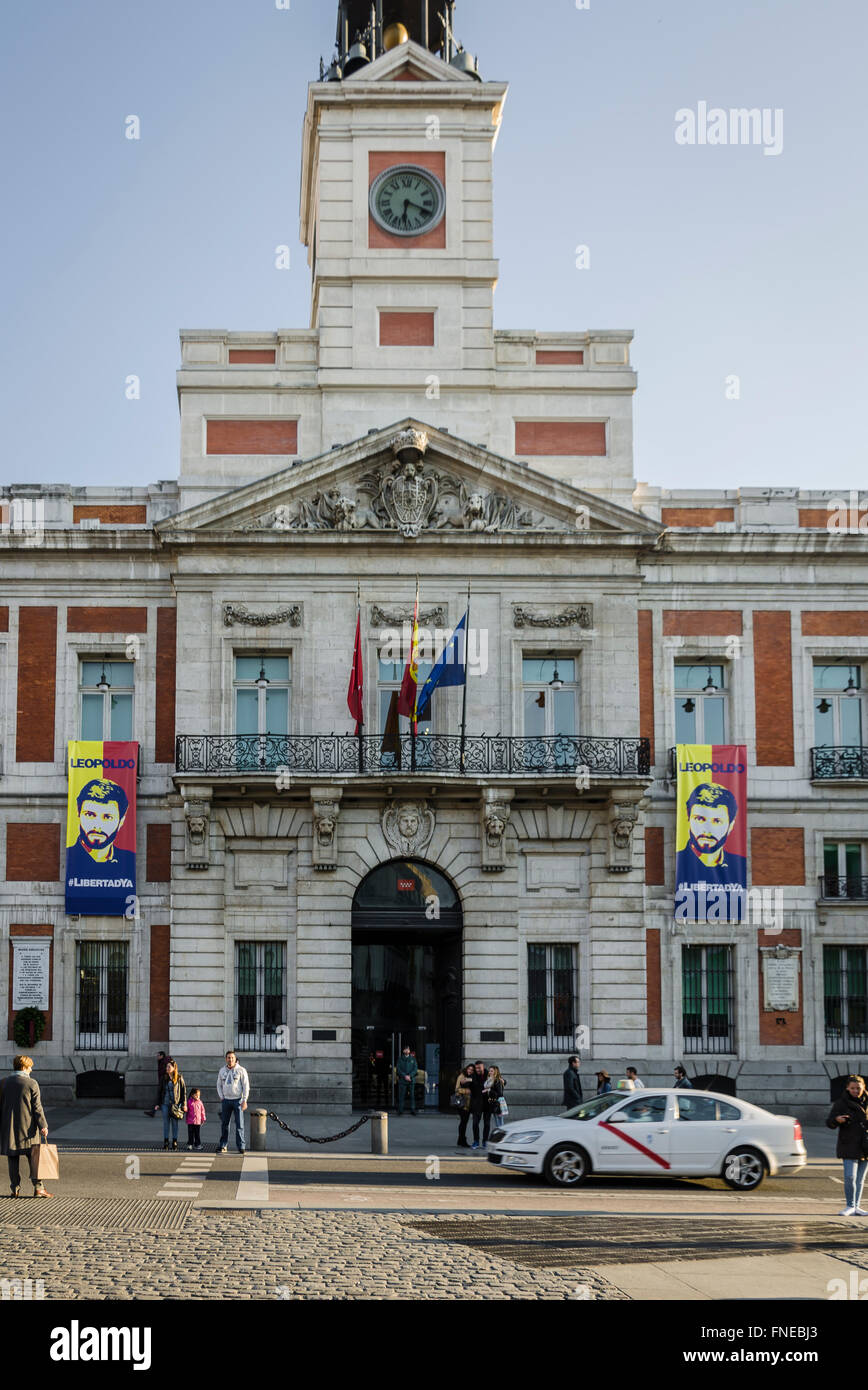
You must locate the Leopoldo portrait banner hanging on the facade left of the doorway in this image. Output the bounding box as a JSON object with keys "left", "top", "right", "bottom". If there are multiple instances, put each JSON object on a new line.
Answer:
{"left": 65, "top": 742, "right": 139, "bottom": 917}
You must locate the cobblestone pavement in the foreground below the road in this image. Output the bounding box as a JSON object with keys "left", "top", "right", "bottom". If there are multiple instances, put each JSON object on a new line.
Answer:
{"left": 0, "top": 1211, "right": 627, "bottom": 1301}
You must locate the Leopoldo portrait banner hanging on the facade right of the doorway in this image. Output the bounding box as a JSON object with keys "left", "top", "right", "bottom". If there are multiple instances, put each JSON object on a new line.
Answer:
{"left": 675, "top": 744, "right": 747, "bottom": 923}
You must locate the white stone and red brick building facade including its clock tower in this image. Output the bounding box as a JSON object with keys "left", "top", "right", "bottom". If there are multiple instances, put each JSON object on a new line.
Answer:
{"left": 0, "top": 7, "right": 868, "bottom": 1116}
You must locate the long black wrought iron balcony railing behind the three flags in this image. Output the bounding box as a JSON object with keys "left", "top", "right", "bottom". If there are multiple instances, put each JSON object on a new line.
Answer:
{"left": 175, "top": 734, "right": 651, "bottom": 777}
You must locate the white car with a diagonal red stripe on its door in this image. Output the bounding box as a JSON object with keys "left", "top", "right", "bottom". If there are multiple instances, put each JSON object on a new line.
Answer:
{"left": 487, "top": 1087, "right": 807, "bottom": 1193}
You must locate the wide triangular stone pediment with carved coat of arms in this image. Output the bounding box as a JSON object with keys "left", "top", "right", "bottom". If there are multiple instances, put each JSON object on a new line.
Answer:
{"left": 157, "top": 420, "right": 659, "bottom": 543}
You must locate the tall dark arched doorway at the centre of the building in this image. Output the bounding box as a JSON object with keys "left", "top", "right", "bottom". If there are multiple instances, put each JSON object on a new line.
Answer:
{"left": 352, "top": 859, "right": 462, "bottom": 1111}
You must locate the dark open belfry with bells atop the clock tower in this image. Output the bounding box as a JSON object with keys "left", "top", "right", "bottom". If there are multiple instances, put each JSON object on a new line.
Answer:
{"left": 332, "top": 0, "right": 479, "bottom": 82}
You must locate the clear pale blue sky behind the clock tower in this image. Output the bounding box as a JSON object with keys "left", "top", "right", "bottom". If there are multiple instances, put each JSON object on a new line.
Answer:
{"left": 0, "top": 0, "right": 868, "bottom": 488}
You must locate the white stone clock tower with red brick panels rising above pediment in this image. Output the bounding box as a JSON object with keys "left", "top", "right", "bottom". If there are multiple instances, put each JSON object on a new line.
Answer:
{"left": 300, "top": 0, "right": 508, "bottom": 441}
